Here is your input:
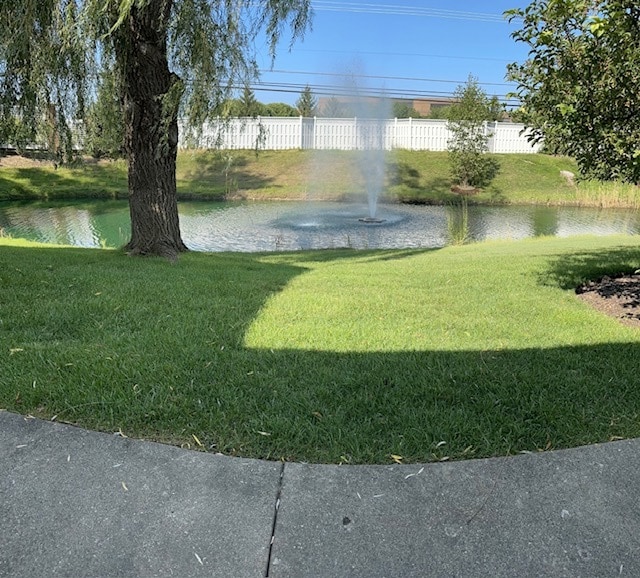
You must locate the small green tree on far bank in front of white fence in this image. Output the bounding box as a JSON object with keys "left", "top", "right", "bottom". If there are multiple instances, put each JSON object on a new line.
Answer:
{"left": 447, "top": 76, "right": 500, "bottom": 187}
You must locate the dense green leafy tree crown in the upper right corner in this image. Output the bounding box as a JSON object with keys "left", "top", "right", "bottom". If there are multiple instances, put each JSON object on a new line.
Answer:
{"left": 505, "top": 0, "right": 640, "bottom": 183}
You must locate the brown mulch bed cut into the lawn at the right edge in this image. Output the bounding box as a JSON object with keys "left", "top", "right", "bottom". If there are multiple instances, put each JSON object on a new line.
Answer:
{"left": 576, "top": 273, "right": 640, "bottom": 328}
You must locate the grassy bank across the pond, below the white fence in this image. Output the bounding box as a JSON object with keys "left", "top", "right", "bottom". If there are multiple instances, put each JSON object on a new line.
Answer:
{"left": 0, "top": 150, "right": 640, "bottom": 208}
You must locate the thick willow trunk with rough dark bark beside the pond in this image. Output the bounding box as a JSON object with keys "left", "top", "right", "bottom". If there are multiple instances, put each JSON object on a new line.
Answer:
{"left": 117, "top": 0, "right": 188, "bottom": 258}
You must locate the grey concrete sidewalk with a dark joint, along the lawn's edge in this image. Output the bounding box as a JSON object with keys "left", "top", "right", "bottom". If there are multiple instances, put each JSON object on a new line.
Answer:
{"left": 0, "top": 412, "right": 640, "bottom": 578}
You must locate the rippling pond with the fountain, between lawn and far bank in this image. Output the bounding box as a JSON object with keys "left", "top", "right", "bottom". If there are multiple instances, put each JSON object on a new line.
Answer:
{"left": 0, "top": 201, "right": 640, "bottom": 252}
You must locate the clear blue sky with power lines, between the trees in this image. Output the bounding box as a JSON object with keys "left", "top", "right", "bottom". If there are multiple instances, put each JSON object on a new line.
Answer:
{"left": 254, "top": 0, "right": 528, "bottom": 104}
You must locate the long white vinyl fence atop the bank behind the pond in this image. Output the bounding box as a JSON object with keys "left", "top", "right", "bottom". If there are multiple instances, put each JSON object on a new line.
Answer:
{"left": 180, "top": 117, "right": 541, "bottom": 153}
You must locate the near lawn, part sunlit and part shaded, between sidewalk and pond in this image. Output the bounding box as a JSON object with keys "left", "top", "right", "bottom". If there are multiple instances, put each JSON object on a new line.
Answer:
{"left": 0, "top": 232, "right": 640, "bottom": 463}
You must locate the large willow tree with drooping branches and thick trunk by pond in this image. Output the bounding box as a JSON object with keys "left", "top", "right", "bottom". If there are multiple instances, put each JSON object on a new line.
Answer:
{"left": 0, "top": 0, "right": 311, "bottom": 257}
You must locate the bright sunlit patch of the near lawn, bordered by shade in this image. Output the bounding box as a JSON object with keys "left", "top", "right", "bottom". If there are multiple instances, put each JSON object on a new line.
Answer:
{"left": 246, "top": 234, "right": 640, "bottom": 352}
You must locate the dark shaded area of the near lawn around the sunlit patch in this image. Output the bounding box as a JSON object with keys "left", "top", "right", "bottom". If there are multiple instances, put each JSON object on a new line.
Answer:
{"left": 0, "top": 247, "right": 640, "bottom": 463}
